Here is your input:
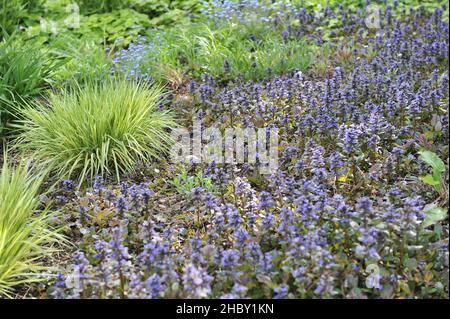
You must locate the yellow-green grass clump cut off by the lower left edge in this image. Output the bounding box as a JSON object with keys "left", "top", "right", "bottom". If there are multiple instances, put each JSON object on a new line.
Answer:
{"left": 0, "top": 159, "right": 65, "bottom": 297}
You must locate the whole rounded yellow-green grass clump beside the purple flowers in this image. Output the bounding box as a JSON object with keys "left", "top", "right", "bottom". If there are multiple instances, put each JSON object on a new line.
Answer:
{"left": 17, "top": 80, "right": 176, "bottom": 185}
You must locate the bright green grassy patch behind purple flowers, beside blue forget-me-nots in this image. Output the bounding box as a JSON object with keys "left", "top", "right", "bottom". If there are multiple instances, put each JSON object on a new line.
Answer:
{"left": 128, "top": 23, "right": 319, "bottom": 81}
